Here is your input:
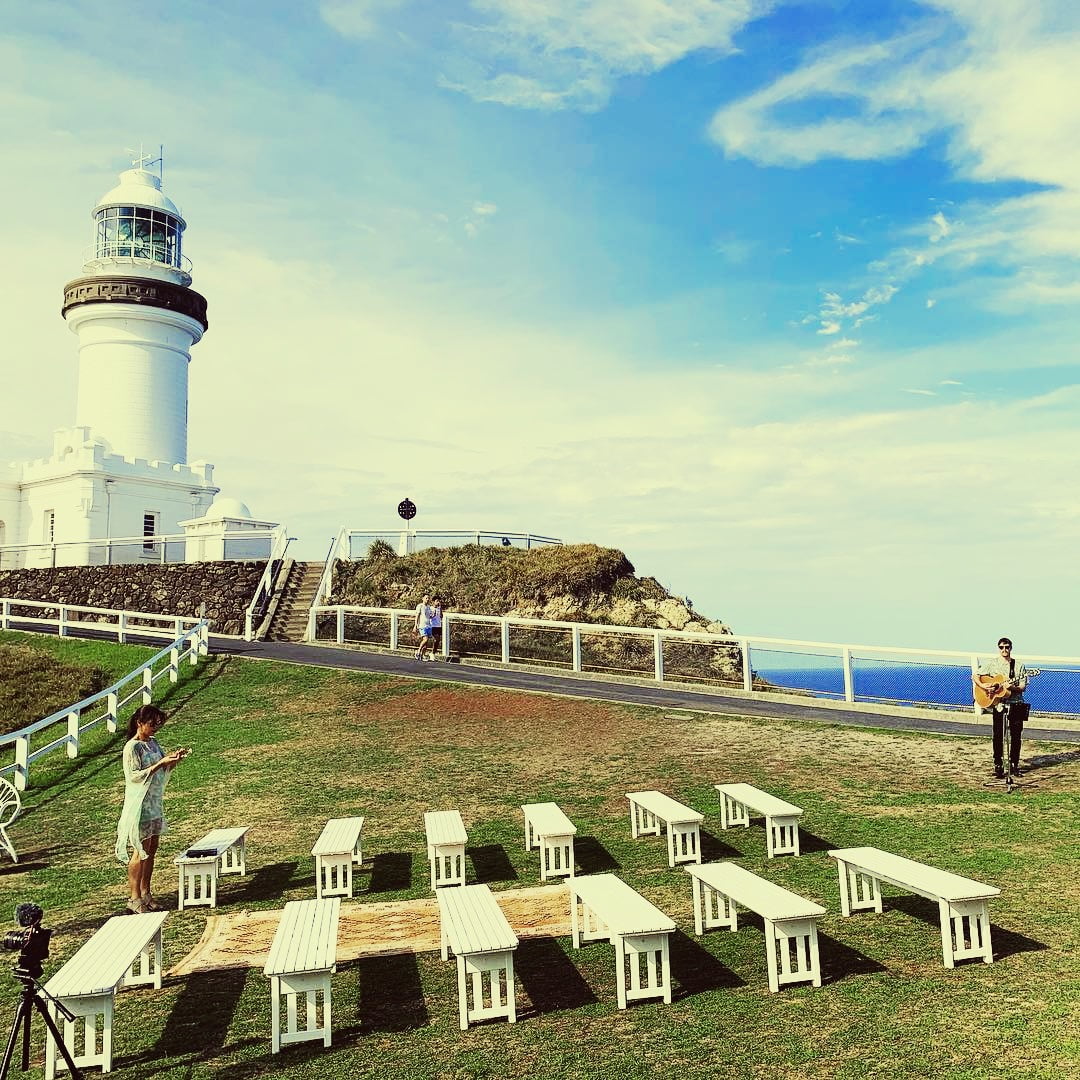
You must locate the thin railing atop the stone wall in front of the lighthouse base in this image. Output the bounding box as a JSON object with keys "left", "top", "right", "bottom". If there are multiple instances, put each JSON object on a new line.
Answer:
{"left": 0, "top": 526, "right": 284, "bottom": 570}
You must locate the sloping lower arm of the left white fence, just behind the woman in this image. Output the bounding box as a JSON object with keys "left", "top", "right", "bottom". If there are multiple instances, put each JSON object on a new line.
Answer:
{"left": 0, "top": 622, "right": 210, "bottom": 791}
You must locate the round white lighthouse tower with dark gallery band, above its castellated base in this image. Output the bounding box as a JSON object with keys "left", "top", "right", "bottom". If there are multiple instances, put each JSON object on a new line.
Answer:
{"left": 63, "top": 151, "right": 207, "bottom": 463}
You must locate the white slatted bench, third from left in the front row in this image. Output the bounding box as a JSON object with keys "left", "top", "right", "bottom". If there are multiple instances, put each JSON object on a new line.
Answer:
{"left": 435, "top": 885, "right": 517, "bottom": 1031}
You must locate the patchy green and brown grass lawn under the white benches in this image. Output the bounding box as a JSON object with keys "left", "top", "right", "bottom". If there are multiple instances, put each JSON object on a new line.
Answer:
{"left": 0, "top": 634, "right": 1080, "bottom": 1080}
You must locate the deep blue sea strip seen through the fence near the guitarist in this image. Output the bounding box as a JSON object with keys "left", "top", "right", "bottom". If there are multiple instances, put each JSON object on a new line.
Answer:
{"left": 754, "top": 662, "right": 1080, "bottom": 715}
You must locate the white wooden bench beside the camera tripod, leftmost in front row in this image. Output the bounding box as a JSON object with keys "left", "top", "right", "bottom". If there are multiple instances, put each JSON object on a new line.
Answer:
{"left": 45, "top": 912, "right": 168, "bottom": 1080}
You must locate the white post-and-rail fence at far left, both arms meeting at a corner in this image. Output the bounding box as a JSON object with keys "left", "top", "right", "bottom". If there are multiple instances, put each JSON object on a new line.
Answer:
{"left": 0, "top": 598, "right": 210, "bottom": 791}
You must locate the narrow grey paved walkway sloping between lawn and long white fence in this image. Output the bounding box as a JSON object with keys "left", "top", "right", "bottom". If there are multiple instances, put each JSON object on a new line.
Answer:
{"left": 211, "top": 635, "right": 1080, "bottom": 743}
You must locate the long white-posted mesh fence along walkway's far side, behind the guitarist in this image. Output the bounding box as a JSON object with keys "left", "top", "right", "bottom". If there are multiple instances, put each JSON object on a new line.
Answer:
{"left": 307, "top": 605, "right": 1080, "bottom": 717}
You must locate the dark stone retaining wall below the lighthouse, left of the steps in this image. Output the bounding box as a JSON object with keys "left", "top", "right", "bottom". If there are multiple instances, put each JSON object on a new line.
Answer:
{"left": 0, "top": 559, "right": 266, "bottom": 634}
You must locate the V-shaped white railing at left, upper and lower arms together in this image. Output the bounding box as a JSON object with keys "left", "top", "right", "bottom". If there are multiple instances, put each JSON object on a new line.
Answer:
{"left": 0, "top": 613, "right": 210, "bottom": 791}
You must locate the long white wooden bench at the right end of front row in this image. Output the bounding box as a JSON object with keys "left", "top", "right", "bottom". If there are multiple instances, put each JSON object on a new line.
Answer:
{"left": 829, "top": 848, "right": 1001, "bottom": 968}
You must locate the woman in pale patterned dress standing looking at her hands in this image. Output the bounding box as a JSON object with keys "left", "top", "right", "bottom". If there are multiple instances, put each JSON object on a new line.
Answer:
{"left": 117, "top": 705, "right": 190, "bottom": 914}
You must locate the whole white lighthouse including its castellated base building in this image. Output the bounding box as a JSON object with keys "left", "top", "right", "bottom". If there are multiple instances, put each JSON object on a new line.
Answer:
{"left": 0, "top": 158, "right": 273, "bottom": 568}
